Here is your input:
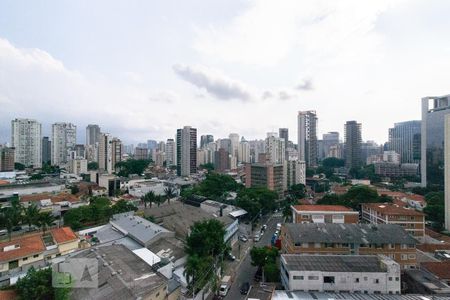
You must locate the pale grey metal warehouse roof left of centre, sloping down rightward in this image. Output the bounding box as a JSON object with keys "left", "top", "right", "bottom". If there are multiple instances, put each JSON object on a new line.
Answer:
{"left": 110, "top": 212, "right": 170, "bottom": 245}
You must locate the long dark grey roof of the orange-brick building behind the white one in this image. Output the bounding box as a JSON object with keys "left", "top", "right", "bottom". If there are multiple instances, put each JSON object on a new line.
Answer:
{"left": 284, "top": 223, "right": 417, "bottom": 245}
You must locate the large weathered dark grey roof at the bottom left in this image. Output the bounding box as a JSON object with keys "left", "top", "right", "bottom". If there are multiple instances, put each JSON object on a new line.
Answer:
{"left": 71, "top": 245, "right": 167, "bottom": 300}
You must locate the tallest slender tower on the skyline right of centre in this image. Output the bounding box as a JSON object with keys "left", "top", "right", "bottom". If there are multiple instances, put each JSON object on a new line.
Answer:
{"left": 298, "top": 110, "right": 317, "bottom": 167}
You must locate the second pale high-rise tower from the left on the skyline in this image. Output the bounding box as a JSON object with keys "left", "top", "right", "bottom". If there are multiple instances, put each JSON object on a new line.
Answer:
{"left": 52, "top": 122, "right": 77, "bottom": 166}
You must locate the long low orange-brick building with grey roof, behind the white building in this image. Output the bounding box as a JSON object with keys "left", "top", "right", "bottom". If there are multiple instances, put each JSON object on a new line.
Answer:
{"left": 280, "top": 223, "right": 417, "bottom": 269}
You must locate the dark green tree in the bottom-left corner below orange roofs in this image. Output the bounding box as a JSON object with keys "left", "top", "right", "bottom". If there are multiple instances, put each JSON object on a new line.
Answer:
{"left": 15, "top": 267, "right": 70, "bottom": 300}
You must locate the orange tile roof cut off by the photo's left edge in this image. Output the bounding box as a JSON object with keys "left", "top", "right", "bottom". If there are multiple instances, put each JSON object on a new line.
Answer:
{"left": 0, "top": 235, "right": 45, "bottom": 262}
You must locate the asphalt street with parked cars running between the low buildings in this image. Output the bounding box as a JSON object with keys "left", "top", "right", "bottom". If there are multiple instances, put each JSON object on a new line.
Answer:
{"left": 225, "top": 216, "right": 282, "bottom": 300}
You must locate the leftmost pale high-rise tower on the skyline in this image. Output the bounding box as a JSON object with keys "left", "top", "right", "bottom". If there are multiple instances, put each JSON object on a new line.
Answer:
{"left": 11, "top": 119, "right": 42, "bottom": 168}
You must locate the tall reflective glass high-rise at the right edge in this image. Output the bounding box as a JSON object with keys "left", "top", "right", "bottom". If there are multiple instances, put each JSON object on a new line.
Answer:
{"left": 420, "top": 95, "right": 450, "bottom": 186}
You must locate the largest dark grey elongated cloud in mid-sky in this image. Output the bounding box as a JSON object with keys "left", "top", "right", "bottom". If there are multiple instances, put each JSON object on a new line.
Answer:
{"left": 173, "top": 64, "right": 252, "bottom": 101}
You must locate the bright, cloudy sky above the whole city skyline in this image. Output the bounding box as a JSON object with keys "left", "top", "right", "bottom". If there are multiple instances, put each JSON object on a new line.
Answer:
{"left": 0, "top": 0, "right": 450, "bottom": 143}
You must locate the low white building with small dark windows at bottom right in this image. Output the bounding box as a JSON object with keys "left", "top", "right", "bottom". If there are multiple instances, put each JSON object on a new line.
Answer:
{"left": 280, "top": 254, "right": 401, "bottom": 294}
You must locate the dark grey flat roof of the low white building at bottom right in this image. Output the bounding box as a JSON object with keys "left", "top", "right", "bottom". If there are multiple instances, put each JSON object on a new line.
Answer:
{"left": 281, "top": 254, "right": 386, "bottom": 273}
